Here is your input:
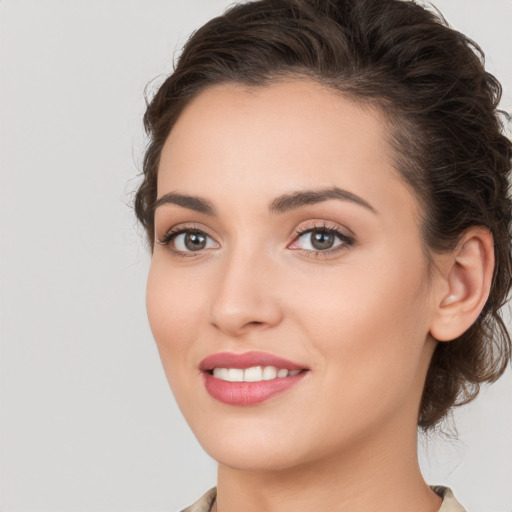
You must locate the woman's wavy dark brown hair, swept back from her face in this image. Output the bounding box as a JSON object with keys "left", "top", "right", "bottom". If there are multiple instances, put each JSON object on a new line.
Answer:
{"left": 135, "top": 0, "right": 512, "bottom": 429}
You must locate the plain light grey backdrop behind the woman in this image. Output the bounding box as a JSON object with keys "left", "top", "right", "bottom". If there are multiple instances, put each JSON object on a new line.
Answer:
{"left": 0, "top": 0, "right": 512, "bottom": 512}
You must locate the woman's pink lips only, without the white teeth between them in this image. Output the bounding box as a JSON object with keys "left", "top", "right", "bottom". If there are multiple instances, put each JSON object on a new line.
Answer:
{"left": 199, "top": 352, "right": 309, "bottom": 405}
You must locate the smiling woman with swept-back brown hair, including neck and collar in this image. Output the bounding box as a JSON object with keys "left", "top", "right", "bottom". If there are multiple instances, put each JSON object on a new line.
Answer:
{"left": 136, "top": 0, "right": 512, "bottom": 512}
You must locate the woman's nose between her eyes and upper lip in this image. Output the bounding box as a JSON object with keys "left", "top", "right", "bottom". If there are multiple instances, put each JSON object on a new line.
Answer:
{"left": 210, "top": 249, "right": 282, "bottom": 337}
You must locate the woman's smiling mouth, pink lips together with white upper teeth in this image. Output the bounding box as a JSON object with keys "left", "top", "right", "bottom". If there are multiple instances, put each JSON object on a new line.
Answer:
{"left": 199, "top": 352, "right": 309, "bottom": 405}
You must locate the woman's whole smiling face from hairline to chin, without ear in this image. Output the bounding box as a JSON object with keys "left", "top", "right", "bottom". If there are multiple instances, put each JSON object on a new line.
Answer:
{"left": 147, "top": 80, "right": 435, "bottom": 470}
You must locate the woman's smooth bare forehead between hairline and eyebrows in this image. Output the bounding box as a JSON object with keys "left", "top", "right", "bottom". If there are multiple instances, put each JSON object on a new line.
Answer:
{"left": 158, "top": 80, "right": 418, "bottom": 220}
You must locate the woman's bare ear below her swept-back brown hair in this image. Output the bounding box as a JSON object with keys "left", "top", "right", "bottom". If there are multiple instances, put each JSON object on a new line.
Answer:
{"left": 430, "top": 226, "right": 494, "bottom": 341}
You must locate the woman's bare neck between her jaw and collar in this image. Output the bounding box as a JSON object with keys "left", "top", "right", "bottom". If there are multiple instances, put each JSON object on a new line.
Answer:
{"left": 217, "top": 422, "right": 441, "bottom": 512}
